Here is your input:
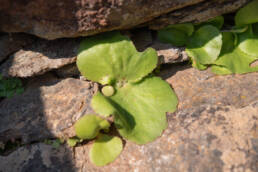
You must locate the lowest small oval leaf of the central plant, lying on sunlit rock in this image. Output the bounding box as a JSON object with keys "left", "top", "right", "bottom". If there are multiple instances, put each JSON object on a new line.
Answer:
{"left": 90, "top": 134, "right": 123, "bottom": 166}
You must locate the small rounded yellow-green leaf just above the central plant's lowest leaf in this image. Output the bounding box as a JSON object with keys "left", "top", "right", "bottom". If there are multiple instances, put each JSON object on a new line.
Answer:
{"left": 75, "top": 114, "right": 110, "bottom": 139}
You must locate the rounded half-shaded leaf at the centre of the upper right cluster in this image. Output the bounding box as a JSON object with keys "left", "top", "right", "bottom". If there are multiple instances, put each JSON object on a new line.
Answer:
{"left": 186, "top": 25, "right": 222, "bottom": 65}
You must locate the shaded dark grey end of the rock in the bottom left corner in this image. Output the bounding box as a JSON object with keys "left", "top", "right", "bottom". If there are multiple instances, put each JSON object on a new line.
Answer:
{"left": 0, "top": 143, "right": 76, "bottom": 172}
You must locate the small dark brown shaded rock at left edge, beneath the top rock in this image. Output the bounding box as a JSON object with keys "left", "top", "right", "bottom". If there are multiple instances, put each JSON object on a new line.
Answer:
{"left": 0, "top": 34, "right": 34, "bottom": 63}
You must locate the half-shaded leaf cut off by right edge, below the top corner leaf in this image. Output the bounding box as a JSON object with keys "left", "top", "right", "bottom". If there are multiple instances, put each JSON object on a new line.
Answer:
{"left": 238, "top": 25, "right": 258, "bottom": 56}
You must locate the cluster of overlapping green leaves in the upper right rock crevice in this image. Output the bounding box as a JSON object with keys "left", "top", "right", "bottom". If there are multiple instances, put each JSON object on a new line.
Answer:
{"left": 158, "top": 0, "right": 258, "bottom": 75}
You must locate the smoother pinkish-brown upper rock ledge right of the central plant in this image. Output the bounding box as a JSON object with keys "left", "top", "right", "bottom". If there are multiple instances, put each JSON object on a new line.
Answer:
{"left": 161, "top": 64, "right": 258, "bottom": 109}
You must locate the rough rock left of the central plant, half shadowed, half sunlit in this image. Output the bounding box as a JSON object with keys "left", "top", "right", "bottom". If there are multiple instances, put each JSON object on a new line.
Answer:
{"left": 0, "top": 75, "right": 93, "bottom": 144}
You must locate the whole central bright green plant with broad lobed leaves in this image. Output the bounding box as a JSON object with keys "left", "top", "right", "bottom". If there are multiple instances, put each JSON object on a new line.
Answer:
{"left": 69, "top": 32, "right": 178, "bottom": 166}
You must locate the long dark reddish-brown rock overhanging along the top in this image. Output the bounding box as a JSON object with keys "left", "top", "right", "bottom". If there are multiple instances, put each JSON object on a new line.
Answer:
{"left": 0, "top": 0, "right": 248, "bottom": 39}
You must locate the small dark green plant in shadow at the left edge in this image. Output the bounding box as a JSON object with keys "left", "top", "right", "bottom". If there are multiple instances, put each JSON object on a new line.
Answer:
{"left": 0, "top": 74, "right": 24, "bottom": 98}
